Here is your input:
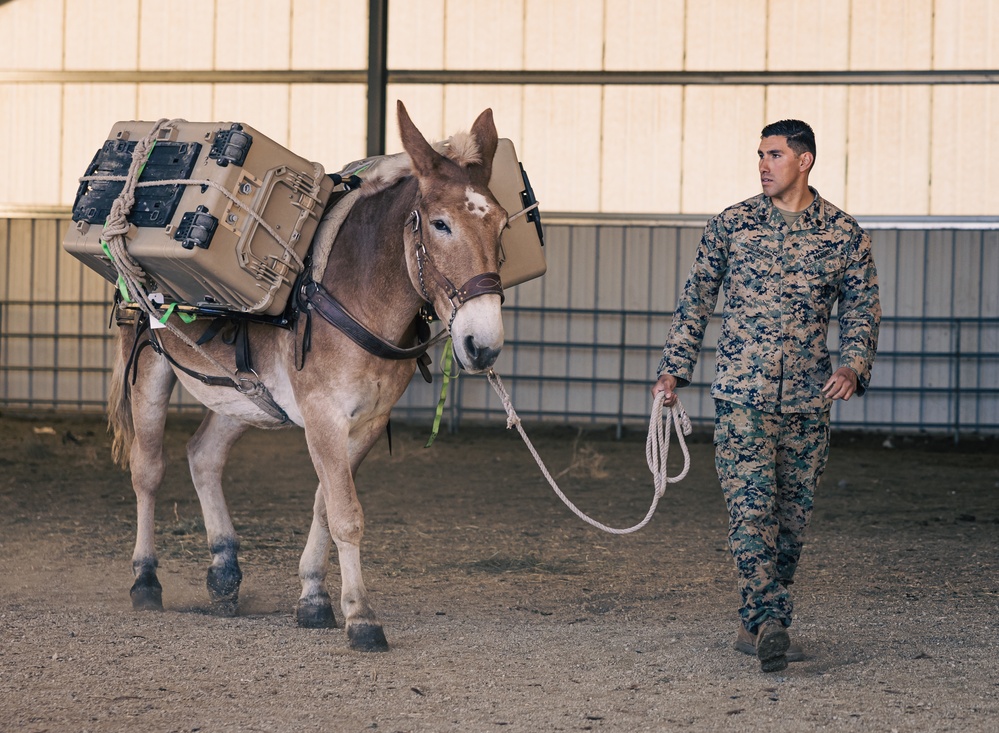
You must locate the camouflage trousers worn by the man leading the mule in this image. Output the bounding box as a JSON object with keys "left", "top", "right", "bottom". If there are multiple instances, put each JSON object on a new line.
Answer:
{"left": 714, "top": 400, "right": 829, "bottom": 632}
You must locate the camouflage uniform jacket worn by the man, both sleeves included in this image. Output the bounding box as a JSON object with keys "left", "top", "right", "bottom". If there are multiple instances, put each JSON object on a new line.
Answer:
{"left": 659, "top": 189, "right": 881, "bottom": 413}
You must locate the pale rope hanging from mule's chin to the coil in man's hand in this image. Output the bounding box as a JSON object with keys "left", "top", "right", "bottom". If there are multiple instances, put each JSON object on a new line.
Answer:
{"left": 486, "top": 369, "right": 691, "bottom": 534}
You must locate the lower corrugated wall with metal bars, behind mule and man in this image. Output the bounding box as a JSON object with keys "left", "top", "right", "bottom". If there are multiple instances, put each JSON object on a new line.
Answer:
{"left": 0, "top": 214, "right": 999, "bottom": 437}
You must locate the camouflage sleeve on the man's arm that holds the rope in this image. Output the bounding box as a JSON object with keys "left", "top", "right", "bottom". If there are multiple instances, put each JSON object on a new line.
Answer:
{"left": 657, "top": 218, "right": 728, "bottom": 387}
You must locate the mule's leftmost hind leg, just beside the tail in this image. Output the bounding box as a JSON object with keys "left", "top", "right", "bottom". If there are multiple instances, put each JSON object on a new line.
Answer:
{"left": 124, "top": 346, "right": 176, "bottom": 611}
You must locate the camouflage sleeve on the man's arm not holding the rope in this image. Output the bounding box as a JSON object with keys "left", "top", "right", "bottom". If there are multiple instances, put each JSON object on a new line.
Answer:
{"left": 839, "top": 231, "right": 881, "bottom": 395}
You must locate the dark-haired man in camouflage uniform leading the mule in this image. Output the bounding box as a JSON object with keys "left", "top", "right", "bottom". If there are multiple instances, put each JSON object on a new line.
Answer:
{"left": 652, "top": 120, "right": 881, "bottom": 672}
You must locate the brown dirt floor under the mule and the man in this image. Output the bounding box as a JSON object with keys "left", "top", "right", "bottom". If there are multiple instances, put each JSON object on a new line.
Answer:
{"left": 0, "top": 414, "right": 999, "bottom": 733}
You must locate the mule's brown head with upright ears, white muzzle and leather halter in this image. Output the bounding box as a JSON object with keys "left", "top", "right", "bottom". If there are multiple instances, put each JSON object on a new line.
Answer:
{"left": 398, "top": 102, "right": 507, "bottom": 373}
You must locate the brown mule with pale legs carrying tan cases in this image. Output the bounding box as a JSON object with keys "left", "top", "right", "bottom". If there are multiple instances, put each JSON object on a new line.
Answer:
{"left": 108, "top": 102, "right": 508, "bottom": 651}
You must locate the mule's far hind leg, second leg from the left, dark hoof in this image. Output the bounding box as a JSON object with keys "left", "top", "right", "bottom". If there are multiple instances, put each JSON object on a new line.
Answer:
{"left": 187, "top": 412, "right": 248, "bottom": 616}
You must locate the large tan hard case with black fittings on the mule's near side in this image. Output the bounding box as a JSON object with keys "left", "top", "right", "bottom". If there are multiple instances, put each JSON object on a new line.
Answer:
{"left": 63, "top": 121, "right": 333, "bottom": 316}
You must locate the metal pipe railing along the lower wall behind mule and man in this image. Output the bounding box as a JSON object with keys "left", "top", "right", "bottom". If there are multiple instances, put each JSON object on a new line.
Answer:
{"left": 0, "top": 301, "right": 999, "bottom": 439}
